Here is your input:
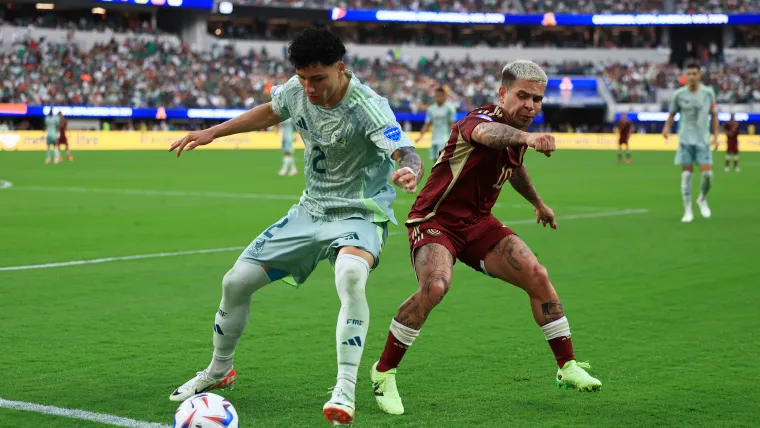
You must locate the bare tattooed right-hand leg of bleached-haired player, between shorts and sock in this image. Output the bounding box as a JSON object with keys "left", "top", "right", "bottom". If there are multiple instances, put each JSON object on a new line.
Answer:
{"left": 485, "top": 235, "right": 565, "bottom": 326}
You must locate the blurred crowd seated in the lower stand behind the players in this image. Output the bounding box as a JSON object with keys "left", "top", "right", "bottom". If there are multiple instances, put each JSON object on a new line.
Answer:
{"left": 0, "top": 39, "right": 760, "bottom": 111}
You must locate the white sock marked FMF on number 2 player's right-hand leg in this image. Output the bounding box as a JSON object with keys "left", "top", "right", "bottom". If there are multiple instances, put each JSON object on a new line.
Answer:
{"left": 335, "top": 254, "right": 369, "bottom": 394}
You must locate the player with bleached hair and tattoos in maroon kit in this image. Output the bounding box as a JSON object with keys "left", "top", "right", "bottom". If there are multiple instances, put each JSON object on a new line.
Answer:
{"left": 370, "top": 60, "right": 601, "bottom": 414}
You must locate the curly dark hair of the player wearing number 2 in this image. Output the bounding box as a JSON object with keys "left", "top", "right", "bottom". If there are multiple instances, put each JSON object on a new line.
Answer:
{"left": 288, "top": 28, "right": 346, "bottom": 69}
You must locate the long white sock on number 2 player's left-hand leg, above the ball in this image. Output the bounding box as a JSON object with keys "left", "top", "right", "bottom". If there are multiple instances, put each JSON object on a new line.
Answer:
{"left": 207, "top": 260, "right": 272, "bottom": 377}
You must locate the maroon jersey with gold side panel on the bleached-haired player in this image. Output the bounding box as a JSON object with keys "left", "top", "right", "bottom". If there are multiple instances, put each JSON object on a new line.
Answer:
{"left": 406, "top": 105, "right": 527, "bottom": 226}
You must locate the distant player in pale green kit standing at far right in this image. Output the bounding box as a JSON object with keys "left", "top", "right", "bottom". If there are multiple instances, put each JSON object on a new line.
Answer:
{"left": 662, "top": 62, "right": 720, "bottom": 223}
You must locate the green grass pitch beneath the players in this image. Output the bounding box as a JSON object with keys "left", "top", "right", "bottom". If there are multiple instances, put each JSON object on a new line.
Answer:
{"left": 0, "top": 150, "right": 760, "bottom": 428}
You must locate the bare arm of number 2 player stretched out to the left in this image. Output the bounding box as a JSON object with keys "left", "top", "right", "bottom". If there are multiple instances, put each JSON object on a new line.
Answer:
{"left": 169, "top": 103, "right": 285, "bottom": 157}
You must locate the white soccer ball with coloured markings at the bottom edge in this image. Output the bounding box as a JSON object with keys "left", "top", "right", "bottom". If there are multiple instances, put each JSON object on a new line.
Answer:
{"left": 172, "top": 393, "right": 239, "bottom": 428}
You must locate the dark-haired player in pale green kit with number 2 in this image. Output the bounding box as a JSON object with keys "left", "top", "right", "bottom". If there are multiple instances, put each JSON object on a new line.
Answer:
{"left": 165, "top": 29, "right": 423, "bottom": 424}
